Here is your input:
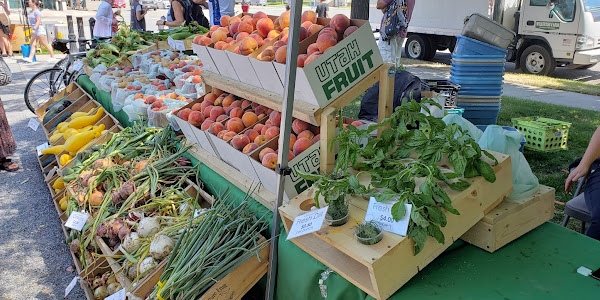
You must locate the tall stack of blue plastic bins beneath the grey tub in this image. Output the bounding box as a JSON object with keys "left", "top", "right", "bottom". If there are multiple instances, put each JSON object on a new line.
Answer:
{"left": 450, "top": 35, "right": 506, "bottom": 125}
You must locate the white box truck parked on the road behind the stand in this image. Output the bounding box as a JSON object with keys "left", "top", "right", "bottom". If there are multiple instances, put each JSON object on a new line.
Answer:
{"left": 369, "top": 0, "right": 600, "bottom": 75}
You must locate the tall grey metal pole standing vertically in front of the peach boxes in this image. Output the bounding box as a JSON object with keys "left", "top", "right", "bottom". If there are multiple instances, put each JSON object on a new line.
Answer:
{"left": 265, "top": 0, "right": 302, "bottom": 300}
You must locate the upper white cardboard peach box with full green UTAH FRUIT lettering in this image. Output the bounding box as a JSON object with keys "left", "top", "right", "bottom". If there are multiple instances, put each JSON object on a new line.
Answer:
{"left": 274, "top": 20, "right": 383, "bottom": 107}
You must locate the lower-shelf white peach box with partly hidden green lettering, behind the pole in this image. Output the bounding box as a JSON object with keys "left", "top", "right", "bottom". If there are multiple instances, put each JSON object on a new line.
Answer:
{"left": 248, "top": 136, "right": 321, "bottom": 202}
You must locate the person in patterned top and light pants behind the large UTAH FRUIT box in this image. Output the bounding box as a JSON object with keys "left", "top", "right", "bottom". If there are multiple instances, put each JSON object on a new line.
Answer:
{"left": 376, "top": 0, "right": 415, "bottom": 68}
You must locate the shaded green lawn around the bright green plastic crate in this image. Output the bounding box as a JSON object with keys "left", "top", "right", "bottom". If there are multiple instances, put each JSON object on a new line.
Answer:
{"left": 342, "top": 96, "right": 600, "bottom": 230}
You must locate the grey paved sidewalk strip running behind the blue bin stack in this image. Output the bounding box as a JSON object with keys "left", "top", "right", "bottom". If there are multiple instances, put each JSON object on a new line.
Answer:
{"left": 406, "top": 65, "right": 600, "bottom": 111}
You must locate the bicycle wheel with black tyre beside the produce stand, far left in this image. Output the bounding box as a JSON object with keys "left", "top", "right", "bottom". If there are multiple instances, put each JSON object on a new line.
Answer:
{"left": 23, "top": 68, "right": 66, "bottom": 113}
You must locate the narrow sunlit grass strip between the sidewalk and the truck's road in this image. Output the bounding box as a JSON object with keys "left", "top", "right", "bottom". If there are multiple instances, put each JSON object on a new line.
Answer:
{"left": 402, "top": 58, "right": 600, "bottom": 96}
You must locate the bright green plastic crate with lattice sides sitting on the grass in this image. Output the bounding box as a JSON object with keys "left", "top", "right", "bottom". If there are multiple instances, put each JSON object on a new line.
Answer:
{"left": 512, "top": 117, "right": 571, "bottom": 151}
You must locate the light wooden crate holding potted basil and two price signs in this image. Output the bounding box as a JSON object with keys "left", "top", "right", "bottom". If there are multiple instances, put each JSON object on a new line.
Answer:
{"left": 280, "top": 153, "right": 512, "bottom": 299}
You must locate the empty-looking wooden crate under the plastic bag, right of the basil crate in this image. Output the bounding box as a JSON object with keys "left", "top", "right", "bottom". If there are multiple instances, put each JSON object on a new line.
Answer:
{"left": 460, "top": 185, "right": 555, "bottom": 253}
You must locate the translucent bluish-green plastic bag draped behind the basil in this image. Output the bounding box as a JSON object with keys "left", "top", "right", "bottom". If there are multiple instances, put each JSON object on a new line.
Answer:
{"left": 478, "top": 125, "right": 539, "bottom": 199}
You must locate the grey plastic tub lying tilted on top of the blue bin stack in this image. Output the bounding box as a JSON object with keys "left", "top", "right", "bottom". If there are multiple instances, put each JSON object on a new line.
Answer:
{"left": 461, "top": 13, "right": 515, "bottom": 49}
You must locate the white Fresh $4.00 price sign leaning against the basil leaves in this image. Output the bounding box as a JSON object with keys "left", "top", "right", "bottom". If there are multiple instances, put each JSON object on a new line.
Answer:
{"left": 365, "top": 197, "right": 412, "bottom": 236}
